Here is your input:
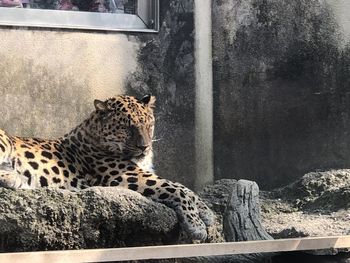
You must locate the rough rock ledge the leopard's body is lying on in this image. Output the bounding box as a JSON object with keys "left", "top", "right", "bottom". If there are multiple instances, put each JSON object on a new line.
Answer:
{"left": 0, "top": 187, "right": 178, "bottom": 252}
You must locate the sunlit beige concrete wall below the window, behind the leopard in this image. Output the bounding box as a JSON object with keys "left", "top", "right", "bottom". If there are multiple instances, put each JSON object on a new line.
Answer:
{"left": 0, "top": 28, "right": 139, "bottom": 137}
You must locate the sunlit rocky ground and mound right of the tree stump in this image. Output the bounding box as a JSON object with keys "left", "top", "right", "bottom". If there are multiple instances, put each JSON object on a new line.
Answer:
{"left": 261, "top": 169, "right": 350, "bottom": 255}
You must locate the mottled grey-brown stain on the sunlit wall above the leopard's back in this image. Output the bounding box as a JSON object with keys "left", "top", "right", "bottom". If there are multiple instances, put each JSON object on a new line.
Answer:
{"left": 0, "top": 56, "right": 92, "bottom": 138}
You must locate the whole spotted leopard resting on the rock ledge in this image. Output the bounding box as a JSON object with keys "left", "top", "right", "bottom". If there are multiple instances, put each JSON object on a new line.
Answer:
{"left": 0, "top": 95, "right": 214, "bottom": 241}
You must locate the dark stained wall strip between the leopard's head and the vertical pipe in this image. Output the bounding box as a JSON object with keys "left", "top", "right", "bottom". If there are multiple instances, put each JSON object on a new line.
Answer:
{"left": 126, "top": 0, "right": 195, "bottom": 187}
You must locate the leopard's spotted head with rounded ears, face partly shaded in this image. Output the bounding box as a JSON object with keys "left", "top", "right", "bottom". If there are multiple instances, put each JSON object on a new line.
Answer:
{"left": 94, "top": 95, "right": 155, "bottom": 159}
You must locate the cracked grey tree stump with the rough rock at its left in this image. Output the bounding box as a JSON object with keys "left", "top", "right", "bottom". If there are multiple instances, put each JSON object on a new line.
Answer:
{"left": 181, "top": 179, "right": 273, "bottom": 263}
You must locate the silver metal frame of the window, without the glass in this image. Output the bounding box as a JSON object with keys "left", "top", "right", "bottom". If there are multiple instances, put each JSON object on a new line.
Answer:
{"left": 0, "top": 0, "right": 159, "bottom": 33}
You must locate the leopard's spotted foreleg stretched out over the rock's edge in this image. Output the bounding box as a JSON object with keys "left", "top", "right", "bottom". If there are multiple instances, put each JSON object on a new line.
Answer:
{"left": 108, "top": 167, "right": 211, "bottom": 240}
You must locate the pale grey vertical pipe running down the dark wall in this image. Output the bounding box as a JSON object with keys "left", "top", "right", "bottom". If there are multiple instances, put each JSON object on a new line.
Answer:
{"left": 194, "top": 0, "right": 214, "bottom": 190}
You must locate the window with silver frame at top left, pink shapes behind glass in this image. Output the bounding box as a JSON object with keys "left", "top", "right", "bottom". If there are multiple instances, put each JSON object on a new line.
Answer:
{"left": 0, "top": 0, "right": 159, "bottom": 32}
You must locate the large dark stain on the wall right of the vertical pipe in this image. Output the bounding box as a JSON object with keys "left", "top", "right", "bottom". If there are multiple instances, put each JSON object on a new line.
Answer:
{"left": 213, "top": 0, "right": 350, "bottom": 188}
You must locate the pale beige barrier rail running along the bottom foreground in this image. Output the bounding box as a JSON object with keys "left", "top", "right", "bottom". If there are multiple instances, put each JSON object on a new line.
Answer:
{"left": 0, "top": 236, "right": 350, "bottom": 263}
